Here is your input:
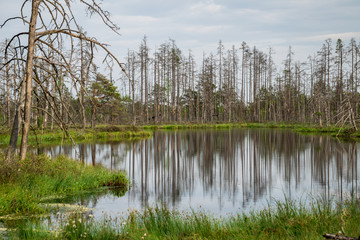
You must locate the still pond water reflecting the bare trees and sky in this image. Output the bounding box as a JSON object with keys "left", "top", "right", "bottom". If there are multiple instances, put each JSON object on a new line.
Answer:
{"left": 43, "top": 129, "right": 360, "bottom": 216}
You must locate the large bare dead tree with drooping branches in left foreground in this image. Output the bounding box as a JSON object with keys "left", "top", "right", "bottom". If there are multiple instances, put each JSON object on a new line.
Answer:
{"left": 1, "top": 0, "right": 126, "bottom": 160}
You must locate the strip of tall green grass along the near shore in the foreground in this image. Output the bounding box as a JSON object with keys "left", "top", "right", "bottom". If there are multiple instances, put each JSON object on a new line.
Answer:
{"left": 10, "top": 197, "right": 360, "bottom": 239}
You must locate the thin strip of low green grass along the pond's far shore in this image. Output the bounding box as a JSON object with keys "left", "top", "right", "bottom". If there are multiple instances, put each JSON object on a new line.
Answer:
{"left": 0, "top": 122, "right": 360, "bottom": 146}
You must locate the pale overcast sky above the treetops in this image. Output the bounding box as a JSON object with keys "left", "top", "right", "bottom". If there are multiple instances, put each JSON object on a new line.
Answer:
{"left": 0, "top": 0, "right": 360, "bottom": 68}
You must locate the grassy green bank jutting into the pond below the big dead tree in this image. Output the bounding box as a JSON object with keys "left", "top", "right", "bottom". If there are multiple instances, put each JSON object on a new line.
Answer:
{"left": 0, "top": 156, "right": 128, "bottom": 216}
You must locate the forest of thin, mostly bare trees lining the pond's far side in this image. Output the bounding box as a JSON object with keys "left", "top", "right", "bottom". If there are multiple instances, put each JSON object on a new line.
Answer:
{"left": 0, "top": 36, "right": 360, "bottom": 128}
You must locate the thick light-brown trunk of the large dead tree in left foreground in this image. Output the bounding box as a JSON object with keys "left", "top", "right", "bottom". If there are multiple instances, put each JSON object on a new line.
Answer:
{"left": 20, "top": 0, "right": 41, "bottom": 160}
